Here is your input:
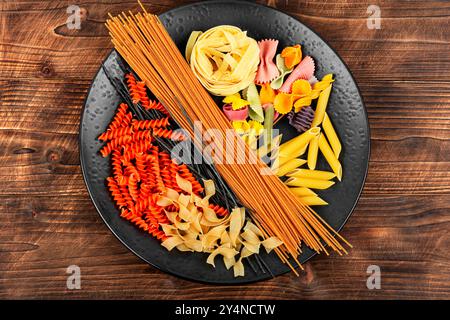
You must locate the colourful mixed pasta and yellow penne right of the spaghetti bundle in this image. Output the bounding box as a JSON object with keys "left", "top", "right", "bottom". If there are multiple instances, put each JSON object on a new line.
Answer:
{"left": 187, "top": 26, "right": 342, "bottom": 206}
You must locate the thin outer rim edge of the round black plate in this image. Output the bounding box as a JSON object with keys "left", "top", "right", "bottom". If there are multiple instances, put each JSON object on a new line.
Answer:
{"left": 78, "top": 0, "right": 371, "bottom": 286}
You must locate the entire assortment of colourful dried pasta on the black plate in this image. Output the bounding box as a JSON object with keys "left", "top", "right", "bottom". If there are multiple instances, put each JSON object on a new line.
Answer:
{"left": 98, "top": 1, "right": 351, "bottom": 277}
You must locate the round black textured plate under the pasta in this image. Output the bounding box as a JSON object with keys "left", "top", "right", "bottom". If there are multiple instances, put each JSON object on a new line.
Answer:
{"left": 80, "top": 1, "right": 370, "bottom": 284}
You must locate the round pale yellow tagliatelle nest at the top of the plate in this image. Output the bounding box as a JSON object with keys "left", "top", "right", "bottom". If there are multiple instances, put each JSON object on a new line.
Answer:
{"left": 186, "top": 25, "right": 260, "bottom": 96}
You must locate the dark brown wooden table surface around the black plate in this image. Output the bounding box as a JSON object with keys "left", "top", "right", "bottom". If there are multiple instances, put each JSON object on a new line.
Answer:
{"left": 0, "top": 0, "right": 450, "bottom": 299}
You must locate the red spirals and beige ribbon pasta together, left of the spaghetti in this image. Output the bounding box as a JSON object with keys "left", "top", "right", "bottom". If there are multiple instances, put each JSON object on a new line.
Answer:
{"left": 98, "top": 74, "right": 281, "bottom": 277}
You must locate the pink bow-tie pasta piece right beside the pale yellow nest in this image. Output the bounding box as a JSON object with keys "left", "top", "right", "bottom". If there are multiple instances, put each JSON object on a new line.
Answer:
{"left": 255, "top": 39, "right": 280, "bottom": 84}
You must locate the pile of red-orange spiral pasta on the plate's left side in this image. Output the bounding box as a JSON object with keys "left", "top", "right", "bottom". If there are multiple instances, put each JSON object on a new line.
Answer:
{"left": 98, "top": 82, "right": 228, "bottom": 241}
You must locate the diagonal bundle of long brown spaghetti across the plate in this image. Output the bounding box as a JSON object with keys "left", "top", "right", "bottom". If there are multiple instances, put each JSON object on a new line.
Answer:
{"left": 106, "top": 5, "right": 350, "bottom": 273}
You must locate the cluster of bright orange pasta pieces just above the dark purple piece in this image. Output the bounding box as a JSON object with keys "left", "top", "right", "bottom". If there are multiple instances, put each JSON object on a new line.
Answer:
{"left": 273, "top": 79, "right": 312, "bottom": 114}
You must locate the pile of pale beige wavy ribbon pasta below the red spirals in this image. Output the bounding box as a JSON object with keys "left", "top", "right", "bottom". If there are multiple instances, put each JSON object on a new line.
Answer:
{"left": 158, "top": 176, "right": 282, "bottom": 277}
